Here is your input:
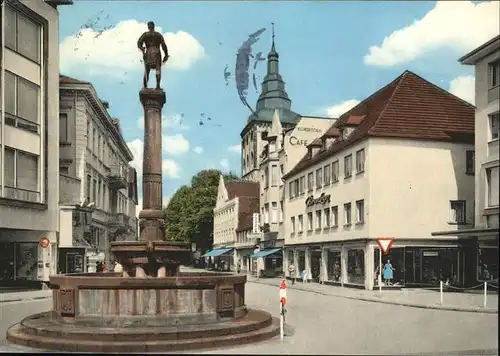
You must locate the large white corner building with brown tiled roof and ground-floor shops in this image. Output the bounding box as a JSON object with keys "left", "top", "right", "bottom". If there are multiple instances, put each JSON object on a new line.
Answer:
{"left": 284, "top": 71, "right": 474, "bottom": 289}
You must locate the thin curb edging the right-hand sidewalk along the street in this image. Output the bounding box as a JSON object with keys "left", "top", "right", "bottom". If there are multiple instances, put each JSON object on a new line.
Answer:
{"left": 252, "top": 281, "right": 498, "bottom": 314}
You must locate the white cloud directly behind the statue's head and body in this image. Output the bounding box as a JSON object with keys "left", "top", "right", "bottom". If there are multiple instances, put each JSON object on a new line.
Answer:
{"left": 59, "top": 20, "right": 205, "bottom": 76}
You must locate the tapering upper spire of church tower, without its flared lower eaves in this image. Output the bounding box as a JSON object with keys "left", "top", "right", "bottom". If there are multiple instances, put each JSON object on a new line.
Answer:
{"left": 256, "top": 22, "right": 291, "bottom": 112}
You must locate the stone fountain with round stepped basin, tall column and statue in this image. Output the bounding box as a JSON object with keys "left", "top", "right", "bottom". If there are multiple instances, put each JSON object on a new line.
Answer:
{"left": 7, "top": 23, "right": 279, "bottom": 352}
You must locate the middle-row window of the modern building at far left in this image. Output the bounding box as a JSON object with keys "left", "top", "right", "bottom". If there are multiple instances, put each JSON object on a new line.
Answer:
{"left": 5, "top": 71, "right": 40, "bottom": 133}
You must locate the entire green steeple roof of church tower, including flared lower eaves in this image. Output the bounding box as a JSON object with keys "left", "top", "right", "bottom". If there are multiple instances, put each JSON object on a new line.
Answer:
{"left": 248, "top": 24, "right": 298, "bottom": 123}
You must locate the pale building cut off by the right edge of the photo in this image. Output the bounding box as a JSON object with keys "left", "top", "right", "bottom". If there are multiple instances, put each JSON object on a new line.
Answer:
{"left": 434, "top": 36, "right": 500, "bottom": 285}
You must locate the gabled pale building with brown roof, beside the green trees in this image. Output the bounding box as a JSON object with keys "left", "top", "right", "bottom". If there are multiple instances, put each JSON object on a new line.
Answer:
{"left": 209, "top": 175, "right": 259, "bottom": 271}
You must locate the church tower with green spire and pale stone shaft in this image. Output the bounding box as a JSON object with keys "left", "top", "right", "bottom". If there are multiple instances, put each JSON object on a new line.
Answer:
{"left": 240, "top": 24, "right": 300, "bottom": 182}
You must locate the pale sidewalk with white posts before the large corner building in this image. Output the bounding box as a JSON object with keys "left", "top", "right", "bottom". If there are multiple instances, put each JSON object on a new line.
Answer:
{"left": 248, "top": 276, "right": 498, "bottom": 314}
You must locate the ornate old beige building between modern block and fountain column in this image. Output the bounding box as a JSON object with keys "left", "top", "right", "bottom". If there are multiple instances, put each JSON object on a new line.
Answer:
{"left": 59, "top": 76, "right": 137, "bottom": 273}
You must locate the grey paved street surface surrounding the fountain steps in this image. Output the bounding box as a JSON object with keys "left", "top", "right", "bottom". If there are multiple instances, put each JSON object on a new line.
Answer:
{"left": 0, "top": 283, "right": 498, "bottom": 355}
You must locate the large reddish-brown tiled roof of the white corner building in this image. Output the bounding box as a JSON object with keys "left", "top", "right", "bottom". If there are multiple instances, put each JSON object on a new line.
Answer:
{"left": 283, "top": 71, "right": 475, "bottom": 178}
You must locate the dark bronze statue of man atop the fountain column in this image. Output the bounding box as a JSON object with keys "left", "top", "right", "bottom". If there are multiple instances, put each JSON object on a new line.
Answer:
{"left": 137, "top": 21, "right": 169, "bottom": 89}
